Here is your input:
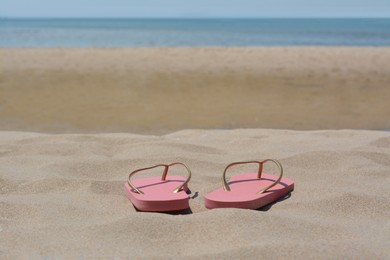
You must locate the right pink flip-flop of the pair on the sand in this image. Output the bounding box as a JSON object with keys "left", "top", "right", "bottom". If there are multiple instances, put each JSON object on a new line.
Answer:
{"left": 205, "top": 159, "right": 294, "bottom": 209}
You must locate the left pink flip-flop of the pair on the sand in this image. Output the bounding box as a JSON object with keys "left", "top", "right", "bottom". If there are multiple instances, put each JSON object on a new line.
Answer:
{"left": 125, "top": 162, "right": 191, "bottom": 212}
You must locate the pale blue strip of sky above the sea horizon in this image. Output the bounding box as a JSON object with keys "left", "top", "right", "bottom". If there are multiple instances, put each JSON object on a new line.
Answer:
{"left": 0, "top": 0, "right": 390, "bottom": 18}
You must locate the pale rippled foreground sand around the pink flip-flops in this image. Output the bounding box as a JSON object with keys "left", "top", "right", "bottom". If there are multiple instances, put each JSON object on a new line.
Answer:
{"left": 0, "top": 129, "right": 390, "bottom": 259}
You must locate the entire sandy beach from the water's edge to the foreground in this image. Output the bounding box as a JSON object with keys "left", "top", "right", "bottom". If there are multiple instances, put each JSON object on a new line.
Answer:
{"left": 0, "top": 47, "right": 390, "bottom": 259}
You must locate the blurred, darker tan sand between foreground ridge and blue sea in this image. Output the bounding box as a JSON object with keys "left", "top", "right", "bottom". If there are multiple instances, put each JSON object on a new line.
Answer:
{"left": 0, "top": 47, "right": 390, "bottom": 134}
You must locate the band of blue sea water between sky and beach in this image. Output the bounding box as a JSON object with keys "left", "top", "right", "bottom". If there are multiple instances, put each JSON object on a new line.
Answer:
{"left": 0, "top": 19, "right": 390, "bottom": 48}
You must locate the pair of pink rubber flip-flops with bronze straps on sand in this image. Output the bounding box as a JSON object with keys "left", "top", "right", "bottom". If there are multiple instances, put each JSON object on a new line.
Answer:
{"left": 125, "top": 159, "right": 294, "bottom": 212}
